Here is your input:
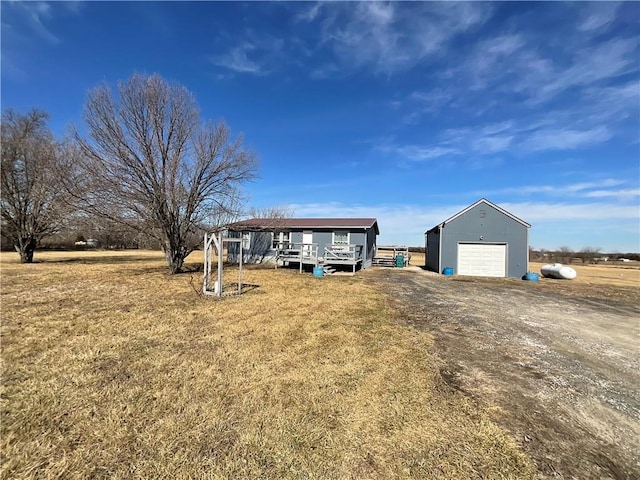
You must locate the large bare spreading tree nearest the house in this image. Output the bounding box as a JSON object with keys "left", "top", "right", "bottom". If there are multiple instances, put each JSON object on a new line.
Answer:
{"left": 73, "top": 74, "right": 257, "bottom": 273}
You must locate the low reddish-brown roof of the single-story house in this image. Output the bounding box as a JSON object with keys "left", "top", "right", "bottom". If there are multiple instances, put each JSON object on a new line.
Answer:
{"left": 227, "top": 218, "right": 380, "bottom": 235}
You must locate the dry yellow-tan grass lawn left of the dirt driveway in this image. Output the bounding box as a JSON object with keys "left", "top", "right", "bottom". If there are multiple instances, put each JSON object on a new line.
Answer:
{"left": 0, "top": 251, "right": 534, "bottom": 479}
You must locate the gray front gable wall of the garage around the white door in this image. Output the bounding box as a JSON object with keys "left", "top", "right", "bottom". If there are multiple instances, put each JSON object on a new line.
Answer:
{"left": 440, "top": 203, "right": 529, "bottom": 278}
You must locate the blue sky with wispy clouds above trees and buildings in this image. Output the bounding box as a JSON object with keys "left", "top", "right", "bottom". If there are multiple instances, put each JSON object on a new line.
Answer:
{"left": 1, "top": 1, "right": 640, "bottom": 252}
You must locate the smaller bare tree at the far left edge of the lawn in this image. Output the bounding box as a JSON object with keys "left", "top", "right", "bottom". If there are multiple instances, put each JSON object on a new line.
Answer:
{"left": 0, "top": 109, "right": 69, "bottom": 263}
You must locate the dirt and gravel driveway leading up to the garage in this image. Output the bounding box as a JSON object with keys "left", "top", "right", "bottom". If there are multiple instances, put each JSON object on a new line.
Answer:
{"left": 367, "top": 268, "right": 640, "bottom": 479}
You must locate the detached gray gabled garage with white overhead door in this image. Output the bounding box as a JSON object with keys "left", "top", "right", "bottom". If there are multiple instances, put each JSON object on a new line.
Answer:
{"left": 425, "top": 198, "right": 531, "bottom": 278}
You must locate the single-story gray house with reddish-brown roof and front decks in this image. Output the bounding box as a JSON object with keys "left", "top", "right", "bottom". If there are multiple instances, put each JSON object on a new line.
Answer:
{"left": 226, "top": 218, "right": 380, "bottom": 271}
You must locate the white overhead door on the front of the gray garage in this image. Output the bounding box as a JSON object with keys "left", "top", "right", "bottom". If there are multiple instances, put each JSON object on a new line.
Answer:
{"left": 456, "top": 243, "right": 507, "bottom": 277}
